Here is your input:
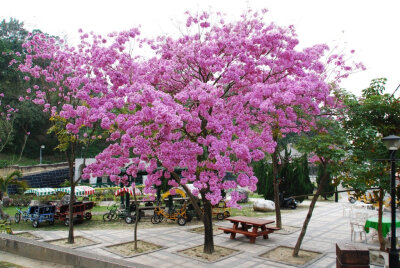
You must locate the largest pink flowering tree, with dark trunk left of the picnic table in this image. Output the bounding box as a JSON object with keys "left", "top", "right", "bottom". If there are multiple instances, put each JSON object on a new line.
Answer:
{"left": 80, "top": 11, "right": 356, "bottom": 253}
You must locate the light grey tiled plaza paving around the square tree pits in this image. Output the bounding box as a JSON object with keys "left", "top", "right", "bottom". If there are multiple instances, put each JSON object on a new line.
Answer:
{"left": 1, "top": 198, "right": 387, "bottom": 268}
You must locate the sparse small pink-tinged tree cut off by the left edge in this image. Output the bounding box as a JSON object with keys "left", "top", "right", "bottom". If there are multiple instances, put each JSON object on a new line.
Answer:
{"left": 0, "top": 93, "right": 18, "bottom": 152}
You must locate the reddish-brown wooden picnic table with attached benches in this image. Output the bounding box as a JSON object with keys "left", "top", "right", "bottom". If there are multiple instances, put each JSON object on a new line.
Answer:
{"left": 218, "top": 216, "right": 279, "bottom": 243}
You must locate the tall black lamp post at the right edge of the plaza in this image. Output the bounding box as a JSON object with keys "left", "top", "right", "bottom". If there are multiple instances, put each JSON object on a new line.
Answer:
{"left": 382, "top": 135, "right": 400, "bottom": 267}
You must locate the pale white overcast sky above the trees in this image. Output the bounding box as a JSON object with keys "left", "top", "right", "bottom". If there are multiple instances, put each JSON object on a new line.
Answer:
{"left": 0, "top": 0, "right": 400, "bottom": 96}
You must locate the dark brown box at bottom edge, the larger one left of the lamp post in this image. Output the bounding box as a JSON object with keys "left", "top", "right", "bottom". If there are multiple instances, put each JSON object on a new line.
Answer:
{"left": 336, "top": 243, "right": 369, "bottom": 268}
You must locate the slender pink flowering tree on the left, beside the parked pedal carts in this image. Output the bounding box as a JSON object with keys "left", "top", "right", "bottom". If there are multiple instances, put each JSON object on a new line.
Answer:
{"left": 11, "top": 33, "right": 114, "bottom": 243}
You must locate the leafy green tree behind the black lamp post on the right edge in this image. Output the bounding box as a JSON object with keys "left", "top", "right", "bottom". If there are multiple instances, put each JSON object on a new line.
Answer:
{"left": 342, "top": 78, "right": 400, "bottom": 250}
